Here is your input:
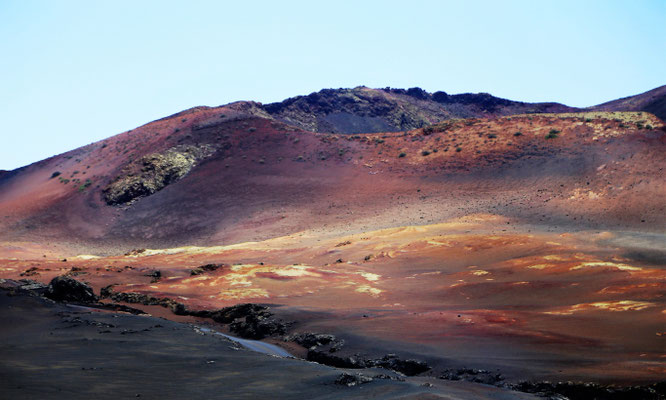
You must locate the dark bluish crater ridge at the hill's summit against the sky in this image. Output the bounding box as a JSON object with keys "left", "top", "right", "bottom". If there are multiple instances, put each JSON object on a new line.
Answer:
{"left": 261, "top": 86, "right": 577, "bottom": 133}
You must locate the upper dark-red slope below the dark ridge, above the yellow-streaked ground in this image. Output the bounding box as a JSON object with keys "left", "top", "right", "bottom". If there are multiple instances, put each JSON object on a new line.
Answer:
{"left": 0, "top": 107, "right": 665, "bottom": 250}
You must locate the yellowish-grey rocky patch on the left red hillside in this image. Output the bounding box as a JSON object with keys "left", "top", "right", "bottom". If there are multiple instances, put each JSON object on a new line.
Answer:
{"left": 102, "top": 145, "right": 213, "bottom": 205}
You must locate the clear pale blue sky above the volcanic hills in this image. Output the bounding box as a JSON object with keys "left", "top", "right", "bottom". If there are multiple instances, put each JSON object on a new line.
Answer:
{"left": 0, "top": 0, "right": 666, "bottom": 169}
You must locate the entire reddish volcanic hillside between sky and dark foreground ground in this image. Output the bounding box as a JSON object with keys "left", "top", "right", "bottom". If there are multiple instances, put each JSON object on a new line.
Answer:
{"left": 0, "top": 88, "right": 666, "bottom": 398}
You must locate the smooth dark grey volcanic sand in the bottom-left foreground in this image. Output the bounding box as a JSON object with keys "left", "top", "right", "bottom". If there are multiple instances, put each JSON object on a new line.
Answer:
{"left": 0, "top": 290, "right": 533, "bottom": 400}
